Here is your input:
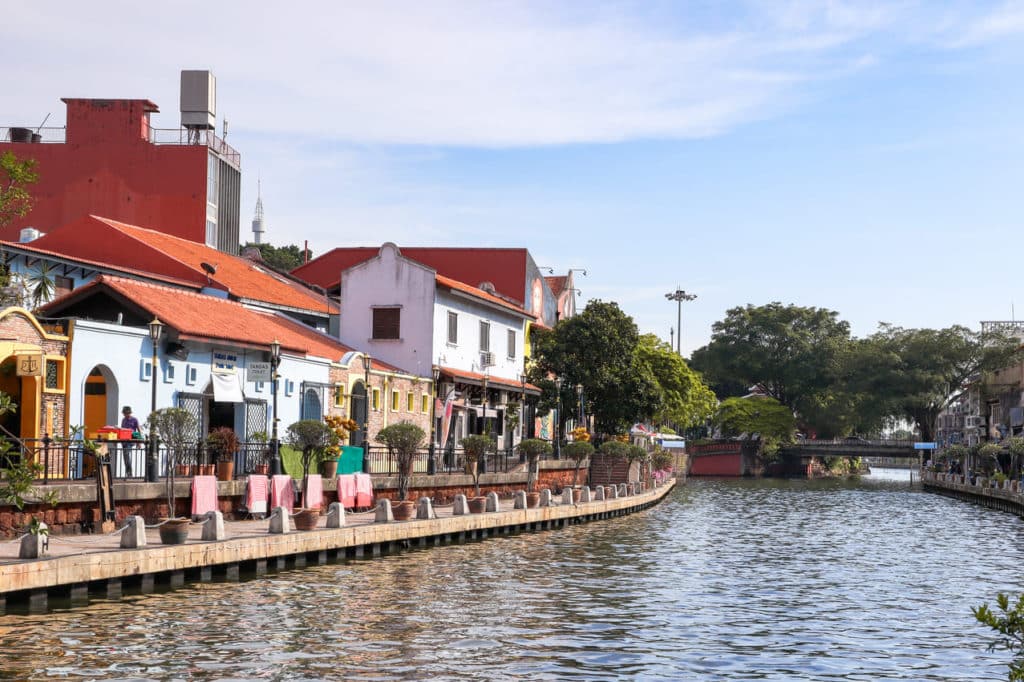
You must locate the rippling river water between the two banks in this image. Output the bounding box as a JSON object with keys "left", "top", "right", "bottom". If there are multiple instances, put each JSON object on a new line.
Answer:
{"left": 0, "top": 470, "right": 1024, "bottom": 681}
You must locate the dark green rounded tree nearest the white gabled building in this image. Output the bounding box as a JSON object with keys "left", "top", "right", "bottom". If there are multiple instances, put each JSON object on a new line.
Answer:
{"left": 528, "top": 300, "right": 659, "bottom": 433}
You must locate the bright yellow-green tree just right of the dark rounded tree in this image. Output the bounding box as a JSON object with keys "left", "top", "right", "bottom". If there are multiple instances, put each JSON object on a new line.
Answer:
{"left": 637, "top": 334, "right": 718, "bottom": 429}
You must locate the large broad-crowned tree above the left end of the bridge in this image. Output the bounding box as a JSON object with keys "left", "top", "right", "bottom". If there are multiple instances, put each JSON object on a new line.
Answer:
{"left": 693, "top": 302, "right": 850, "bottom": 414}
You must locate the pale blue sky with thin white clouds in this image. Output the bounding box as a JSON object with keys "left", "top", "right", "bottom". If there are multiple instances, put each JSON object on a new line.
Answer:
{"left": 0, "top": 0, "right": 1024, "bottom": 354}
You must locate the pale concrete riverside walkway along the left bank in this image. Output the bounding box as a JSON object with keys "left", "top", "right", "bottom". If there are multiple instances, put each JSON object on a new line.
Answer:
{"left": 0, "top": 479, "right": 675, "bottom": 608}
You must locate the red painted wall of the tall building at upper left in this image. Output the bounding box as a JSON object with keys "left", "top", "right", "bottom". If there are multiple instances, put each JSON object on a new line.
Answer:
{"left": 0, "top": 99, "right": 208, "bottom": 242}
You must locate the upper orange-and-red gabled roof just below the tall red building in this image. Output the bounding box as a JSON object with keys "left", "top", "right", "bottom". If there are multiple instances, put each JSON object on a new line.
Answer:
{"left": 24, "top": 216, "right": 337, "bottom": 314}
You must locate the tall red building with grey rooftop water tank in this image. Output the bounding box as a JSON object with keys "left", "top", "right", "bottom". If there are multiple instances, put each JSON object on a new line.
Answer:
{"left": 0, "top": 71, "right": 242, "bottom": 253}
